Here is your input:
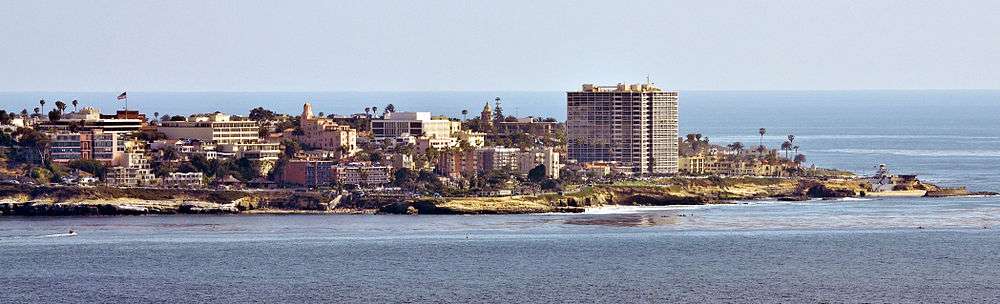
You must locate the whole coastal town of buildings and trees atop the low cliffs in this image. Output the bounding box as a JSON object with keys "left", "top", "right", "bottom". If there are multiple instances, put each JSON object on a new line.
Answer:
{"left": 0, "top": 83, "right": 804, "bottom": 198}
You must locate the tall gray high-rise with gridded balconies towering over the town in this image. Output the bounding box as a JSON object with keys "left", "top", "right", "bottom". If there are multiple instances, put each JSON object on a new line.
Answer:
{"left": 566, "top": 84, "right": 677, "bottom": 175}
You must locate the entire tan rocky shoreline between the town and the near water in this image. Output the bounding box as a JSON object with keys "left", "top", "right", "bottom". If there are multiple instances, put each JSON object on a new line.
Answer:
{"left": 0, "top": 177, "right": 996, "bottom": 216}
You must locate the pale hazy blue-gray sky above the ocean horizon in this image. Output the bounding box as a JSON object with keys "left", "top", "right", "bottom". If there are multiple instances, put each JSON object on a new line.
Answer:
{"left": 0, "top": 0, "right": 1000, "bottom": 92}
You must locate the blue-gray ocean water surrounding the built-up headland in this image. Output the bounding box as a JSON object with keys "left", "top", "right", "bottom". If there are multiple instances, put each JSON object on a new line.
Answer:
{"left": 0, "top": 91, "right": 1000, "bottom": 303}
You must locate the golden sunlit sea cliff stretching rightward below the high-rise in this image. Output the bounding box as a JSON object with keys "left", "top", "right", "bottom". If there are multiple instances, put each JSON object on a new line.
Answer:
{"left": 379, "top": 177, "right": 952, "bottom": 214}
